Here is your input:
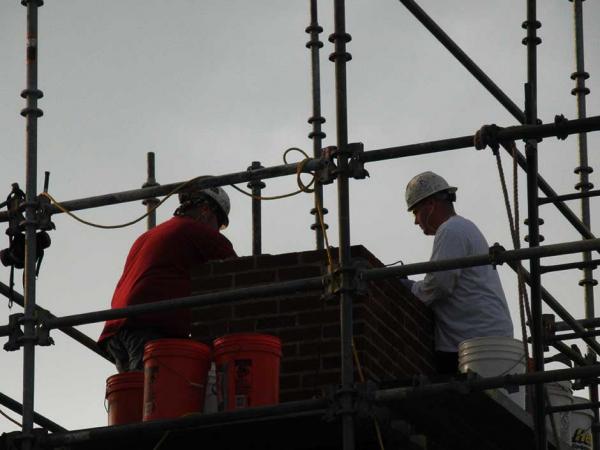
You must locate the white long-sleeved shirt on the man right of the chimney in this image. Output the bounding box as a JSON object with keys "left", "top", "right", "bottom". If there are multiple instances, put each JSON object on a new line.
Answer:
{"left": 412, "top": 215, "right": 513, "bottom": 352}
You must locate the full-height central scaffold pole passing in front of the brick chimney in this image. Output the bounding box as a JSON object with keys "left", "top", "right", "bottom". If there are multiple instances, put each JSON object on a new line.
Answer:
{"left": 329, "top": 0, "right": 355, "bottom": 450}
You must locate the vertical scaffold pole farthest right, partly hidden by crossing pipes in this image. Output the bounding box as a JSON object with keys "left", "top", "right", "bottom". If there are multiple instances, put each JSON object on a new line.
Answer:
{"left": 569, "top": 0, "right": 600, "bottom": 450}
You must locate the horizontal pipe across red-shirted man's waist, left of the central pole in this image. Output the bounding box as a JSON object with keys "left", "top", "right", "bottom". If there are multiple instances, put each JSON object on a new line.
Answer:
{"left": 41, "top": 277, "right": 323, "bottom": 330}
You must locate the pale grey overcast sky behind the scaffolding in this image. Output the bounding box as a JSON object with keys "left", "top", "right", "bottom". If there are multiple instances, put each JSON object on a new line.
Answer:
{"left": 0, "top": 0, "right": 600, "bottom": 432}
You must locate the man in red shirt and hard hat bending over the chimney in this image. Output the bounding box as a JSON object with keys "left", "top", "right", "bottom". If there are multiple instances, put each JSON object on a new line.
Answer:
{"left": 98, "top": 180, "right": 236, "bottom": 372}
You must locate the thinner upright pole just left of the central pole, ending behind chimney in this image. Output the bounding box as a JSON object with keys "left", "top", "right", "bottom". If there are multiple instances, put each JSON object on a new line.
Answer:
{"left": 306, "top": 0, "right": 327, "bottom": 250}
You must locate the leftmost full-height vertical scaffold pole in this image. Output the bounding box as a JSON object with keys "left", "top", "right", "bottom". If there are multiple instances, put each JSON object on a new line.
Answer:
{"left": 21, "top": 0, "right": 44, "bottom": 450}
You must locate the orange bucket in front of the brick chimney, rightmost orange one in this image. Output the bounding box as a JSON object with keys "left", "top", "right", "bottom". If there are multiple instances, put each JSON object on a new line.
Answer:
{"left": 213, "top": 333, "right": 281, "bottom": 411}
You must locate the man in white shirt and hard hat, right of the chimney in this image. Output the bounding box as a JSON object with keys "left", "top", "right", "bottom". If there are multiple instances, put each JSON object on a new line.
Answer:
{"left": 404, "top": 172, "right": 513, "bottom": 374}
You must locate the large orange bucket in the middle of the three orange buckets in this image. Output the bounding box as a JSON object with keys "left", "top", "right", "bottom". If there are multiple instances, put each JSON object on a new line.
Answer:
{"left": 143, "top": 339, "right": 211, "bottom": 421}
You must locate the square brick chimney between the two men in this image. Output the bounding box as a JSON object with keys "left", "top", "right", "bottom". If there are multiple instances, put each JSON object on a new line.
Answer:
{"left": 192, "top": 246, "right": 433, "bottom": 402}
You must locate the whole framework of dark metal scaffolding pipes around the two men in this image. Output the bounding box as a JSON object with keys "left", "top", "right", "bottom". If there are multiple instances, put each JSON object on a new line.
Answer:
{"left": 0, "top": 0, "right": 600, "bottom": 450}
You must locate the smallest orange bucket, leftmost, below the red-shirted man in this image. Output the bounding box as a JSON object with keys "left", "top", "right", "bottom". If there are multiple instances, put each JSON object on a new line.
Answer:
{"left": 105, "top": 371, "right": 144, "bottom": 426}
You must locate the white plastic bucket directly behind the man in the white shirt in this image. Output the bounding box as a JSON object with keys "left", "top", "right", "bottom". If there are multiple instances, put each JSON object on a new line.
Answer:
{"left": 458, "top": 336, "right": 525, "bottom": 409}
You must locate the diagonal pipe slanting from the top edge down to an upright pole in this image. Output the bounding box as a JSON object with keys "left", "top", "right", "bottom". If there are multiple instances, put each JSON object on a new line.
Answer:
{"left": 400, "top": 0, "right": 525, "bottom": 123}
